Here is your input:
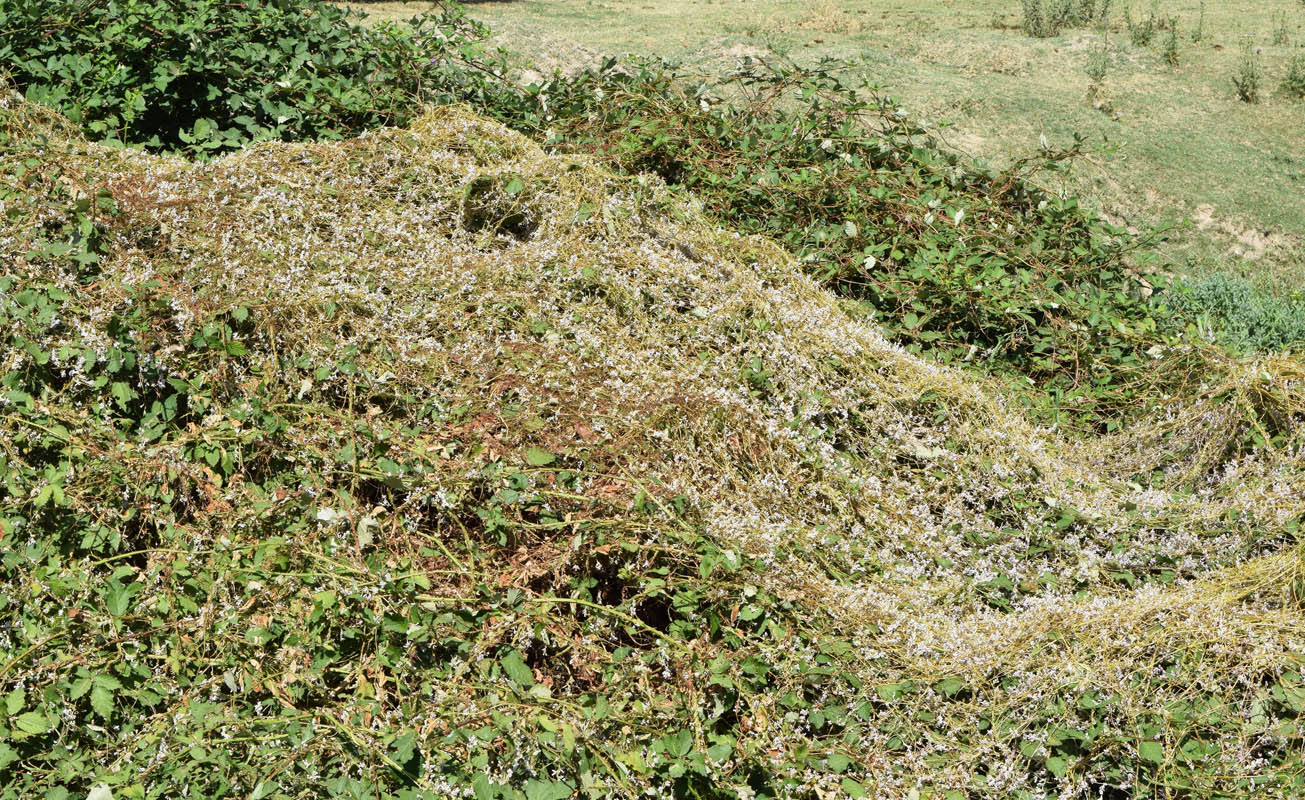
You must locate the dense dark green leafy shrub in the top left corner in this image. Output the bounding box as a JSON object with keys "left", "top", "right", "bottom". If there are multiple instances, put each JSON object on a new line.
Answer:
{"left": 0, "top": 0, "right": 514, "bottom": 153}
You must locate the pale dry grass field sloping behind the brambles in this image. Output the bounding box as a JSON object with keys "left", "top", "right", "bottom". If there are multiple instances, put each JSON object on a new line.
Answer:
{"left": 367, "top": 0, "right": 1305, "bottom": 294}
